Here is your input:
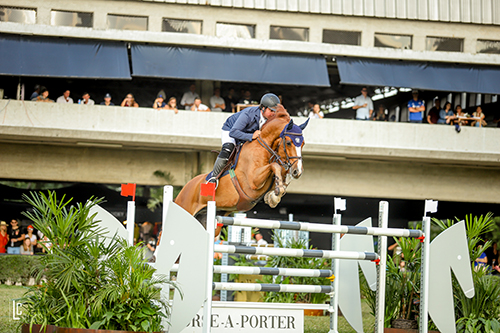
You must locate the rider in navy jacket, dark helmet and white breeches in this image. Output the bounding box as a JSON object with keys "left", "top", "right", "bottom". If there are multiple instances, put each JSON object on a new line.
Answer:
{"left": 208, "top": 93, "right": 280, "bottom": 183}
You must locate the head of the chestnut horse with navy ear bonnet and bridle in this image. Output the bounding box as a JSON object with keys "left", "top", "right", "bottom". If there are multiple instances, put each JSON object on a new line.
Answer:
{"left": 276, "top": 119, "right": 309, "bottom": 178}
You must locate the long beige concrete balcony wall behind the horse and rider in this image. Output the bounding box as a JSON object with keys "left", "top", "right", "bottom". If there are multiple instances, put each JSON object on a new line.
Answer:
{"left": 0, "top": 100, "right": 500, "bottom": 203}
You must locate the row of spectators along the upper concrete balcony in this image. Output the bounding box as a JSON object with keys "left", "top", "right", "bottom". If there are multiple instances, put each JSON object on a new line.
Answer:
{"left": 26, "top": 83, "right": 500, "bottom": 128}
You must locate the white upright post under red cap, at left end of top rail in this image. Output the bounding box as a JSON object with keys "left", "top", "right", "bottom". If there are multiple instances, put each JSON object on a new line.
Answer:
{"left": 202, "top": 201, "right": 216, "bottom": 333}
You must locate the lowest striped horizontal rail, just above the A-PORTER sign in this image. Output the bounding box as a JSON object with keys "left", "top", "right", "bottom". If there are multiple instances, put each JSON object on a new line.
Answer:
{"left": 213, "top": 282, "right": 332, "bottom": 294}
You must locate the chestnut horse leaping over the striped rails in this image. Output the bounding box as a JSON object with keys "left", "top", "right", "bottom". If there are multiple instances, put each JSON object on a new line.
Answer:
{"left": 175, "top": 105, "right": 307, "bottom": 224}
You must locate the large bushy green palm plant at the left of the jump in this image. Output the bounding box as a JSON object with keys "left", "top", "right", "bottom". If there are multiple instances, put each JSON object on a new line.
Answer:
{"left": 22, "top": 191, "right": 176, "bottom": 333}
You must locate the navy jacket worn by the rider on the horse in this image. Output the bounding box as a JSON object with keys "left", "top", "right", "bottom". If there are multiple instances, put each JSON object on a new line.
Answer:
{"left": 222, "top": 106, "right": 260, "bottom": 142}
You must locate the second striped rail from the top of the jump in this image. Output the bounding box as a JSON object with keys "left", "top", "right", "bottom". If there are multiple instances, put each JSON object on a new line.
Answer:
{"left": 214, "top": 245, "right": 378, "bottom": 260}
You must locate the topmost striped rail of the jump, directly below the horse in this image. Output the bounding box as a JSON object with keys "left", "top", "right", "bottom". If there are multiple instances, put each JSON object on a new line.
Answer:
{"left": 217, "top": 216, "right": 423, "bottom": 238}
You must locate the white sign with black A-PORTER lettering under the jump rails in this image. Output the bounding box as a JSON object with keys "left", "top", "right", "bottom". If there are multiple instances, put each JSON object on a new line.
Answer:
{"left": 181, "top": 307, "right": 304, "bottom": 333}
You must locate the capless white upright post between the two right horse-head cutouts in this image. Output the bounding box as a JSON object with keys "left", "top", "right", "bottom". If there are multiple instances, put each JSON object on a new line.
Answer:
{"left": 375, "top": 201, "right": 389, "bottom": 333}
